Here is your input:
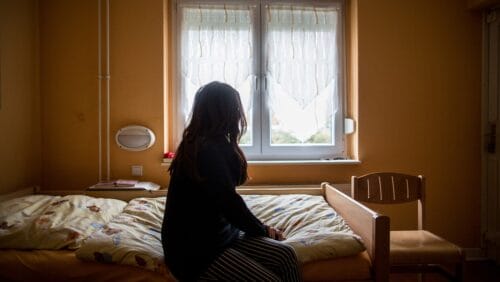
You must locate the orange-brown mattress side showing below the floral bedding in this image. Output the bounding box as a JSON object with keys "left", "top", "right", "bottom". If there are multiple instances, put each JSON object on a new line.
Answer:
{"left": 0, "top": 249, "right": 370, "bottom": 282}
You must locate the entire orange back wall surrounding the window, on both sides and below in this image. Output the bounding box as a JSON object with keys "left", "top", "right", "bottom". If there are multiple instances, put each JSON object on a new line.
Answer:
{"left": 40, "top": 0, "right": 481, "bottom": 247}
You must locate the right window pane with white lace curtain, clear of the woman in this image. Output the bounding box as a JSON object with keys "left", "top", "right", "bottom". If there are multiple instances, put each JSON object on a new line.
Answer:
{"left": 265, "top": 5, "right": 339, "bottom": 146}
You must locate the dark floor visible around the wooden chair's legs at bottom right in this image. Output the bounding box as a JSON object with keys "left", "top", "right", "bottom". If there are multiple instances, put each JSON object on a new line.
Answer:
{"left": 390, "top": 260, "right": 500, "bottom": 282}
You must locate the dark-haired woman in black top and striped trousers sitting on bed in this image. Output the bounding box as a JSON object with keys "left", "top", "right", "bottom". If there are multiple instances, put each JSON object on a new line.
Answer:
{"left": 162, "top": 82, "right": 300, "bottom": 281}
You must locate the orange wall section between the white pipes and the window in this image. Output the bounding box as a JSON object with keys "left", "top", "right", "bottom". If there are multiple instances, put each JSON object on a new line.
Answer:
{"left": 110, "top": 0, "right": 167, "bottom": 186}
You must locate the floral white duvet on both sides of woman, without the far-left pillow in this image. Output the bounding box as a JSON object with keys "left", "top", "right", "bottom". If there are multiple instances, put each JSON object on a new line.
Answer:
{"left": 76, "top": 195, "right": 364, "bottom": 273}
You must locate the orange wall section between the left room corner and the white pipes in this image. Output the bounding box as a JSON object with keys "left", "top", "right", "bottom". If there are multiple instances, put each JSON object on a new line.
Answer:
{"left": 39, "top": 0, "right": 98, "bottom": 192}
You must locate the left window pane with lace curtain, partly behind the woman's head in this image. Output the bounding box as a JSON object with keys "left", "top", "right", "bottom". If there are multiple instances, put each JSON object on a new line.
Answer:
{"left": 180, "top": 5, "right": 256, "bottom": 145}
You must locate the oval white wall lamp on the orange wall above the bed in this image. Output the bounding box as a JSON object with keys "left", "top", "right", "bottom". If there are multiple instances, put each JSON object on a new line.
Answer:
{"left": 115, "top": 125, "right": 155, "bottom": 151}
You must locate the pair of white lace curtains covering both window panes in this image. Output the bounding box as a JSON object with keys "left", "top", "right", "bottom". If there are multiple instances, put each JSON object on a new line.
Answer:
{"left": 180, "top": 4, "right": 339, "bottom": 144}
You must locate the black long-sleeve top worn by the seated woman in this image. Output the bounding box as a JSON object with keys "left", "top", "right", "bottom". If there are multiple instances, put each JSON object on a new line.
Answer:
{"left": 162, "top": 138, "right": 267, "bottom": 281}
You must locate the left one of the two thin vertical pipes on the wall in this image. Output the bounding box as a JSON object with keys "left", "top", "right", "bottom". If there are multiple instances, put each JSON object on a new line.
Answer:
{"left": 97, "top": 0, "right": 102, "bottom": 182}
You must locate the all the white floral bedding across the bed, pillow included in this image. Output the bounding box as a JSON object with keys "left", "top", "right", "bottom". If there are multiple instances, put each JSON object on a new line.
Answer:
{"left": 0, "top": 194, "right": 365, "bottom": 273}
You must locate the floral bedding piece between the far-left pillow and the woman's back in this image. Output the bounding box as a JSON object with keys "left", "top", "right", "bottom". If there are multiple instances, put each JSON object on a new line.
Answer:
{"left": 76, "top": 197, "right": 168, "bottom": 274}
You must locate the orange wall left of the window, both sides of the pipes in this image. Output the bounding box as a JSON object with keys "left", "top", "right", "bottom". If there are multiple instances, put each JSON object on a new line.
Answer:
{"left": 40, "top": 0, "right": 166, "bottom": 189}
